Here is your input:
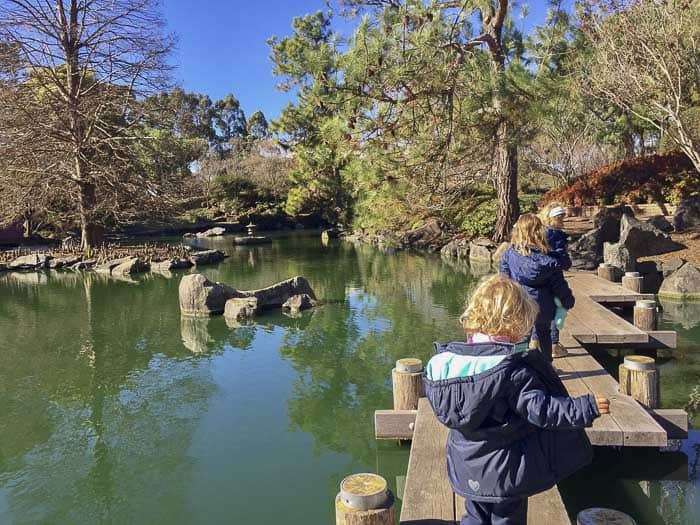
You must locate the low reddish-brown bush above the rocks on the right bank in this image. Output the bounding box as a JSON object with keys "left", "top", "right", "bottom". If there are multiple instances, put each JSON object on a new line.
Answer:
{"left": 542, "top": 151, "right": 700, "bottom": 206}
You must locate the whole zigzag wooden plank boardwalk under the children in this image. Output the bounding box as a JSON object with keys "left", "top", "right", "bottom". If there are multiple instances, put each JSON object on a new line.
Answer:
{"left": 388, "top": 273, "right": 675, "bottom": 525}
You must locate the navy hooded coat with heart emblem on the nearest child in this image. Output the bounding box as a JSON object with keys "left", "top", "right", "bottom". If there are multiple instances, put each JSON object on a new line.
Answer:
{"left": 424, "top": 343, "right": 600, "bottom": 502}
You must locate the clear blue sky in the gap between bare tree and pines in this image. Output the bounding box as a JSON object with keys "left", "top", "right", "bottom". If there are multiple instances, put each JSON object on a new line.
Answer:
{"left": 163, "top": 0, "right": 568, "bottom": 120}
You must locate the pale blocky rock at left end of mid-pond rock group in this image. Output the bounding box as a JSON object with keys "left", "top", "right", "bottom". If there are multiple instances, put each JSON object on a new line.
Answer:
{"left": 178, "top": 273, "right": 241, "bottom": 317}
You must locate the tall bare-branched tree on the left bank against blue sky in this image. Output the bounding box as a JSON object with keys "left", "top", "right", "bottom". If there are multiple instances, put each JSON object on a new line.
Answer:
{"left": 0, "top": 0, "right": 174, "bottom": 249}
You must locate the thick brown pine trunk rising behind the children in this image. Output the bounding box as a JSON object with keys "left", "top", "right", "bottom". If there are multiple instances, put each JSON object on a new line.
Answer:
{"left": 493, "top": 120, "right": 520, "bottom": 242}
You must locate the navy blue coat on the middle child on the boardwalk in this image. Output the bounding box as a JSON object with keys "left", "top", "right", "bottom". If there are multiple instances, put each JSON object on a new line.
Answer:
{"left": 500, "top": 246, "right": 574, "bottom": 325}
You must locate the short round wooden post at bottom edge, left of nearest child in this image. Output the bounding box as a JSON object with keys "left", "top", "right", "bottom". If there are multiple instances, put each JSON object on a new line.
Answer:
{"left": 335, "top": 474, "right": 395, "bottom": 525}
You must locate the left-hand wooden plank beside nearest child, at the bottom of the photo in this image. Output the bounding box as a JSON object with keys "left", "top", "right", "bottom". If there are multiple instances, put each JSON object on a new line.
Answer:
{"left": 400, "top": 398, "right": 455, "bottom": 525}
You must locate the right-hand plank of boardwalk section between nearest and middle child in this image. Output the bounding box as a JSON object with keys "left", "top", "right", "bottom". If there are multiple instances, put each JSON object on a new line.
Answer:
{"left": 555, "top": 332, "right": 668, "bottom": 447}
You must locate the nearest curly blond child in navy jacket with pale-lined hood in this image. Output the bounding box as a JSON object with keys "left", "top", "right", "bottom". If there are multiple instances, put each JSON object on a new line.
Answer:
{"left": 424, "top": 275, "right": 609, "bottom": 525}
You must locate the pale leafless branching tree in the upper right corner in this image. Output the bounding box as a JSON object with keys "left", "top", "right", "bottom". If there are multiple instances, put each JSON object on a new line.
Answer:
{"left": 583, "top": 0, "right": 700, "bottom": 171}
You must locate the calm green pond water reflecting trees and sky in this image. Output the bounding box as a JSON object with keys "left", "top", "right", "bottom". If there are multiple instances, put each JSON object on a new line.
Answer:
{"left": 0, "top": 232, "right": 700, "bottom": 525}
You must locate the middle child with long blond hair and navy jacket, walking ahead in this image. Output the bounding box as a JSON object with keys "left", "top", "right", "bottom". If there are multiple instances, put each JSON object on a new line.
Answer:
{"left": 500, "top": 213, "right": 574, "bottom": 361}
